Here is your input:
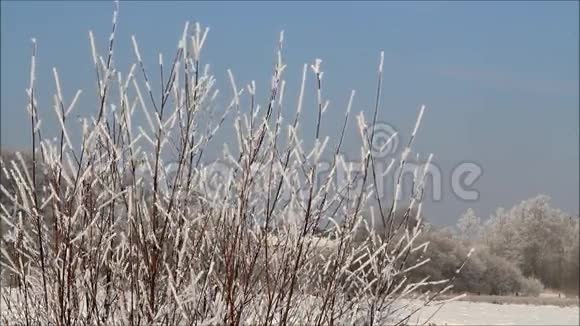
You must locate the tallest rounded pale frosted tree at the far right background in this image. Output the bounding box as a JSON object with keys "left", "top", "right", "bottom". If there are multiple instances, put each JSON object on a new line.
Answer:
{"left": 485, "top": 195, "right": 579, "bottom": 288}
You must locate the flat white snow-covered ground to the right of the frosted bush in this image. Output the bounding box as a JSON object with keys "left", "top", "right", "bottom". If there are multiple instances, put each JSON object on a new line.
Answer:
{"left": 410, "top": 301, "right": 580, "bottom": 325}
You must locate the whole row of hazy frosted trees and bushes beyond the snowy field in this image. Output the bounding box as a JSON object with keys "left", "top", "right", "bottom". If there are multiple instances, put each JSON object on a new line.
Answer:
{"left": 414, "top": 195, "right": 580, "bottom": 305}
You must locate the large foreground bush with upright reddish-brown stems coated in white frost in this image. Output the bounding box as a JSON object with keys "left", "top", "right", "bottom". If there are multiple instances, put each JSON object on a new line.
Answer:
{"left": 0, "top": 4, "right": 470, "bottom": 325}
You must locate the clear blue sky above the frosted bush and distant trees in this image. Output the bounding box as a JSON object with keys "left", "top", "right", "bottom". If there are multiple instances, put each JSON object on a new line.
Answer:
{"left": 1, "top": 1, "right": 579, "bottom": 224}
